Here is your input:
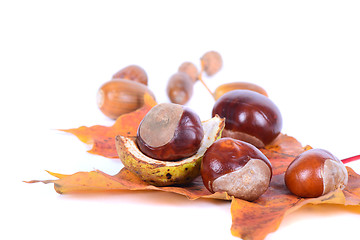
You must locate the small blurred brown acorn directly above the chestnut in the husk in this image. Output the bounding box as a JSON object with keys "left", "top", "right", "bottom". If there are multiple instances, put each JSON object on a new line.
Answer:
{"left": 166, "top": 72, "right": 194, "bottom": 105}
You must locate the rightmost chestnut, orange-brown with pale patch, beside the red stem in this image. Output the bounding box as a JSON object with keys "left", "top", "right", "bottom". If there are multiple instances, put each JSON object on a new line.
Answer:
{"left": 285, "top": 149, "right": 348, "bottom": 197}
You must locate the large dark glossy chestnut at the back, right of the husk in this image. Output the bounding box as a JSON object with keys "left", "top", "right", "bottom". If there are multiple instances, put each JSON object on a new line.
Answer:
{"left": 212, "top": 89, "right": 282, "bottom": 147}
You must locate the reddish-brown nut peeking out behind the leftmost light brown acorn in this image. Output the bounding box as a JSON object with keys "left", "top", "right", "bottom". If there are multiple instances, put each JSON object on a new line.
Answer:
{"left": 112, "top": 65, "right": 148, "bottom": 85}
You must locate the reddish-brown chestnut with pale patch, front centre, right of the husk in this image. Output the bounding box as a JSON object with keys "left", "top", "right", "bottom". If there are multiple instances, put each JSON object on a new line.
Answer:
{"left": 200, "top": 138, "right": 272, "bottom": 201}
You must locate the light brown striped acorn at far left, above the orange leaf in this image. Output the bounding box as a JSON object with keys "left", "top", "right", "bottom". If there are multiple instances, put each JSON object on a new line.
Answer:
{"left": 97, "top": 79, "right": 155, "bottom": 119}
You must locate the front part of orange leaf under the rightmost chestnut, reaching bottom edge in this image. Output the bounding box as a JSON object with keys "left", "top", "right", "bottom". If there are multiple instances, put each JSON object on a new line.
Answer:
{"left": 231, "top": 167, "right": 360, "bottom": 240}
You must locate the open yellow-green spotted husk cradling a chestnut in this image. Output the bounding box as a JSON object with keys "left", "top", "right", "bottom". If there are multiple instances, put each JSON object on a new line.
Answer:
{"left": 115, "top": 116, "right": 225, "bottom": 186}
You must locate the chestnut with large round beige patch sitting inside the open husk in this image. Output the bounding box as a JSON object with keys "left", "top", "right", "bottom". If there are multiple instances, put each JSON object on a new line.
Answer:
{"left": 137, "top": 103, "right": 204, "bottom": 161}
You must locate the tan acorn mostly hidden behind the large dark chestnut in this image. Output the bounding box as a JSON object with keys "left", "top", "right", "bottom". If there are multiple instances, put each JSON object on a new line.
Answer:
{"left": 214, "top": 82, "right": 268, "bottom": 100}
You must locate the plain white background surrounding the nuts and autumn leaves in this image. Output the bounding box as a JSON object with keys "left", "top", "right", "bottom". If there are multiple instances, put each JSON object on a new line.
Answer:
{"left": 0, "top": 0, "right": 360, "bottom": 239}
